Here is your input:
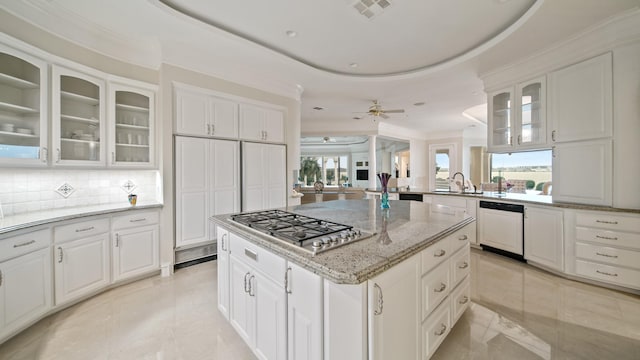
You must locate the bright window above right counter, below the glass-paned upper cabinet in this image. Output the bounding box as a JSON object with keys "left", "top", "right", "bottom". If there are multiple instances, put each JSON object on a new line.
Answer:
{"left": 490, "top": 150, "right": 552, "bottom": 193}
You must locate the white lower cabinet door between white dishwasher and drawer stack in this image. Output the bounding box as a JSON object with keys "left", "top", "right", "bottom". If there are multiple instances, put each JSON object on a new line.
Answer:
{"left": 524, "top": 205, "right": 564, "bottom": 272}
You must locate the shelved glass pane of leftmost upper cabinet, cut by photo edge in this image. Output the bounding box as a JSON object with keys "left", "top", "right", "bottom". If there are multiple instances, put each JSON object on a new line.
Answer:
{"left": 0, "top": 52, "right": 41, "bottom": 159}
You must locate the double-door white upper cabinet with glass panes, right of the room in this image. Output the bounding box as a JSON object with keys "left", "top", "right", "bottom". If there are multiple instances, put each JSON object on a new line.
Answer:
{"left": 487, "top": 77, "right": 547, "bottom": 152}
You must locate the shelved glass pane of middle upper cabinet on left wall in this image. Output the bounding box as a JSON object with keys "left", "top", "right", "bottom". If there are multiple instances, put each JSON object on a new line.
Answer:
{"left": 60, "top": 75, "right": 101, "bottom": 161}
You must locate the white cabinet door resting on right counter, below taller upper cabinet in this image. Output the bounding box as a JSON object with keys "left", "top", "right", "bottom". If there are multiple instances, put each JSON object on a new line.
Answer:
{"left": 552, "top": 139, "right": 613, "bottom": 206}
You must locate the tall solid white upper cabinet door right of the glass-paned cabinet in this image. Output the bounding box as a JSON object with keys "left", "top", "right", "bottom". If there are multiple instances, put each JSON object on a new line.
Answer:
{"left": 548, "top": 52, "right": 613, "bottom": 143}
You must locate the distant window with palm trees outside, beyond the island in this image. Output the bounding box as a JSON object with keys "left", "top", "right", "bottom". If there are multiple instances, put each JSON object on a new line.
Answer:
{"left": 298, "top": 155, "right": 350, "bottom": 187}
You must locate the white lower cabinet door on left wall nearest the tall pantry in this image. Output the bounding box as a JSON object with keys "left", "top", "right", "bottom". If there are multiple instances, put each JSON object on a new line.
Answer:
{"left": 112, "top": 225, "right": 160, "bottom": 281}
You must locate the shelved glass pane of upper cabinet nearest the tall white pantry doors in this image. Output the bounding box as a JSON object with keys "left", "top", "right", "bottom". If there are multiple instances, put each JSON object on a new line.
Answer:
{"left": 115, "top": 91, "right": 150, "bottom": 163}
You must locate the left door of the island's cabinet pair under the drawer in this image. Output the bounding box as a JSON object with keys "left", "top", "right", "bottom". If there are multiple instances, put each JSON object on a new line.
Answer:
{"left": 229, "top": 255, "right": 255, "bottom": 349}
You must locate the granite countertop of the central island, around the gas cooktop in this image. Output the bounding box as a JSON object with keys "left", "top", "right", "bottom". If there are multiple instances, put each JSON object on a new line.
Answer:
{"left": 211, "top": 200, "right": 475, "bottom": 284}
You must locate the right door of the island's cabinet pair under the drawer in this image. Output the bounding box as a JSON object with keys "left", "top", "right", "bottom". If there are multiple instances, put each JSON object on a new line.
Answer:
{"left": 254, "top": 271, "right": 287, "bottom": 360}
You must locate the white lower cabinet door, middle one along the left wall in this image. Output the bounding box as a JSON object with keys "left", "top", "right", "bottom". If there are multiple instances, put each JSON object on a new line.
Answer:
{"left": 54, "top": 233, "right": 110, "bottom": 304}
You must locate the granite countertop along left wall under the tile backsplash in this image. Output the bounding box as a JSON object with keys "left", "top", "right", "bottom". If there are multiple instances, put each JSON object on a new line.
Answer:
{"left": 0, "top": 202, "right": 162, "bottom": 235}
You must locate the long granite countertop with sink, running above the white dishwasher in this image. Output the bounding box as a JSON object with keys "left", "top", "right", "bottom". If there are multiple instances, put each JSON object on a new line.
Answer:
{"left": 365, "top": 188, "right": 640, "bottom": 214}
